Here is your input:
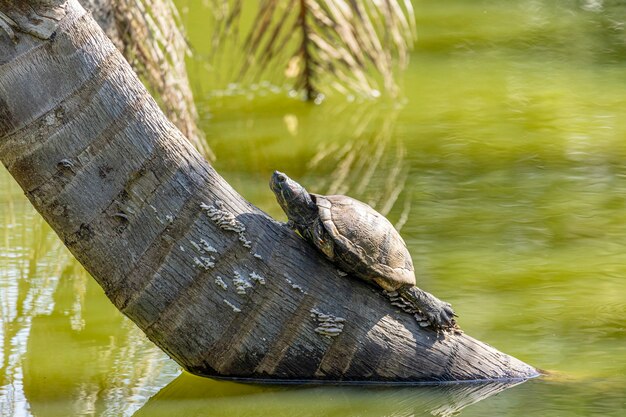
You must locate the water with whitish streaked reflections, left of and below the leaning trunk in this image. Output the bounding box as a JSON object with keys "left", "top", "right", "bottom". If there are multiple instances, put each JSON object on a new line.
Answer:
{"left": 0, "top": 180, "right": 178, "bottom": 416}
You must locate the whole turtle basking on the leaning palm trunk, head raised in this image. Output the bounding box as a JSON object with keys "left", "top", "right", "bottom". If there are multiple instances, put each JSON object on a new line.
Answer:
{"left": 270, "top": 171, "right": 456, "bottom": 331}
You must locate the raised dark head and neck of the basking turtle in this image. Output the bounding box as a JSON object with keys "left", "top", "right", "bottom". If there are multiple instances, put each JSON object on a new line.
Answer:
{"left": 270, "top": 171, "right": 319, "bottom": 226}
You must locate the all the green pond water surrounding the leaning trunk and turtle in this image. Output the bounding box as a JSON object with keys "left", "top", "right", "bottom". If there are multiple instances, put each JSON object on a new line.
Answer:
{"left": 0, "top": 0, "right": 626, "bottom": 416}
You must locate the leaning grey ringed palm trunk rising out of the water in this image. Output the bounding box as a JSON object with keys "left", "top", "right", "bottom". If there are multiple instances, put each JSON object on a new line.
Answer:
{"left": 0, "top": 0, "right": 537, "bottom": 383}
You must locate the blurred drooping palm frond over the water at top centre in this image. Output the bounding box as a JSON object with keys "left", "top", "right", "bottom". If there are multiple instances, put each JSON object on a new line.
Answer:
{"left": 211, "top": 0, "right": 416, "bottom": 100}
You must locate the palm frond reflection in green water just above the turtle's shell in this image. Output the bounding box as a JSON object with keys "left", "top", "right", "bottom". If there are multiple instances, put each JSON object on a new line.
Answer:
{"left": 305, "top": 102, "right": 410, "bottom": 224}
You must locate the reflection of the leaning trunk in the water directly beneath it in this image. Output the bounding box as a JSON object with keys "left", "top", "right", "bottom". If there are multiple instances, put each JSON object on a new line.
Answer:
{"left": 134, "top": 373, "right": 520, "bottom": 417}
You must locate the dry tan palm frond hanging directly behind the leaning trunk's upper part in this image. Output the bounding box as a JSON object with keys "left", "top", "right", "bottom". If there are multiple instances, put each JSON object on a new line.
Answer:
{"left": 81, "top": 0, "right": 215, "bottom": 160}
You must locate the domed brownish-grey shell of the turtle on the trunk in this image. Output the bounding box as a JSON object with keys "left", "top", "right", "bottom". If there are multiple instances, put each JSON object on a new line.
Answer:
{"left": 312, "top": 194, "right": 415, "bottom": 291}
